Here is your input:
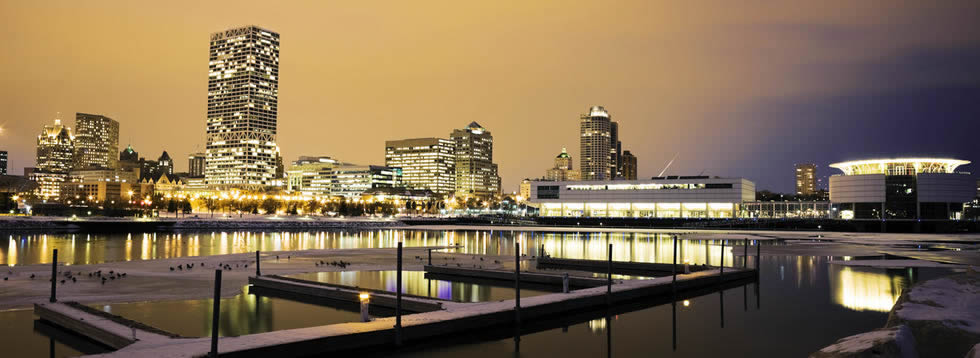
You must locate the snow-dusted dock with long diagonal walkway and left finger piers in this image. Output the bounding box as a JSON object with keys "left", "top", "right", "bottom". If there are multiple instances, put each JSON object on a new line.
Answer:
{"left": 35, "top": 268, "right": 757, "bottom": 358}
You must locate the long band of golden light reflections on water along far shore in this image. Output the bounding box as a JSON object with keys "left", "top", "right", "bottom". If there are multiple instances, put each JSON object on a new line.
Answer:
{"left": 0, "top": 230, "right": 734, "bottom": 266}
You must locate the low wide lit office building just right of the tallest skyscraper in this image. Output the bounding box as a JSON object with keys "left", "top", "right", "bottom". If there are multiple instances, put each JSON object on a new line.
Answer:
{"left": 286, "top": 156, "right": 402, "bottom": 197}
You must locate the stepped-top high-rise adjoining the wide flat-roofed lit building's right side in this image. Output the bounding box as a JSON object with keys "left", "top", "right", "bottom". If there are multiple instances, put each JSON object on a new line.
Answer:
{"left": 450, "top": 122, "right": 500, "bottom": 198}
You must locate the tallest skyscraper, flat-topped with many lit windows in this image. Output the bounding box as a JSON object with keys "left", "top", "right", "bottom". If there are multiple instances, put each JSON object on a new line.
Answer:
{"left": 204, "top": 26, "right": 279, "bottom": 187}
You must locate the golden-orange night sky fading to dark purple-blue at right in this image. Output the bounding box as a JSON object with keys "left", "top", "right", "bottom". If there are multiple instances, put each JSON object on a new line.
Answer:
{"left": 0, "top": 0, "right": 980, "bottom": 192}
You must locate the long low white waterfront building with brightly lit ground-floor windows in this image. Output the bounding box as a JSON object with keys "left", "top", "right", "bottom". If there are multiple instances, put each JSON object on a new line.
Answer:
{"left": 530, "top": 176, "right": 755, "bottom": 218}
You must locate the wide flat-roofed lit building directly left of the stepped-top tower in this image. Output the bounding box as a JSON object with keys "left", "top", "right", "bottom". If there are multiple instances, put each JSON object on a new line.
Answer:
{"left": 385, "top": 138, "right": 456, "bottom": 194}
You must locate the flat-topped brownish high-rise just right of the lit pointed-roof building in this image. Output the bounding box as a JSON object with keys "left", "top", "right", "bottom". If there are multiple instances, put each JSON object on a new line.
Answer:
{"left": 74, "top": 113, "right": 119, "bottom": 169}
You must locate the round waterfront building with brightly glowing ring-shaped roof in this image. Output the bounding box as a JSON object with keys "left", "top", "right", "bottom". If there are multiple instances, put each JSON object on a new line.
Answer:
{"left": 830, "top": 158, "right": 976, "bottom": 220}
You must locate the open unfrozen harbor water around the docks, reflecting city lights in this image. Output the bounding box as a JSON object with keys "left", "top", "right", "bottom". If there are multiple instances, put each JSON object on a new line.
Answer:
{"left": 0, "top": 231, "right": 948, "bottom": 357}
